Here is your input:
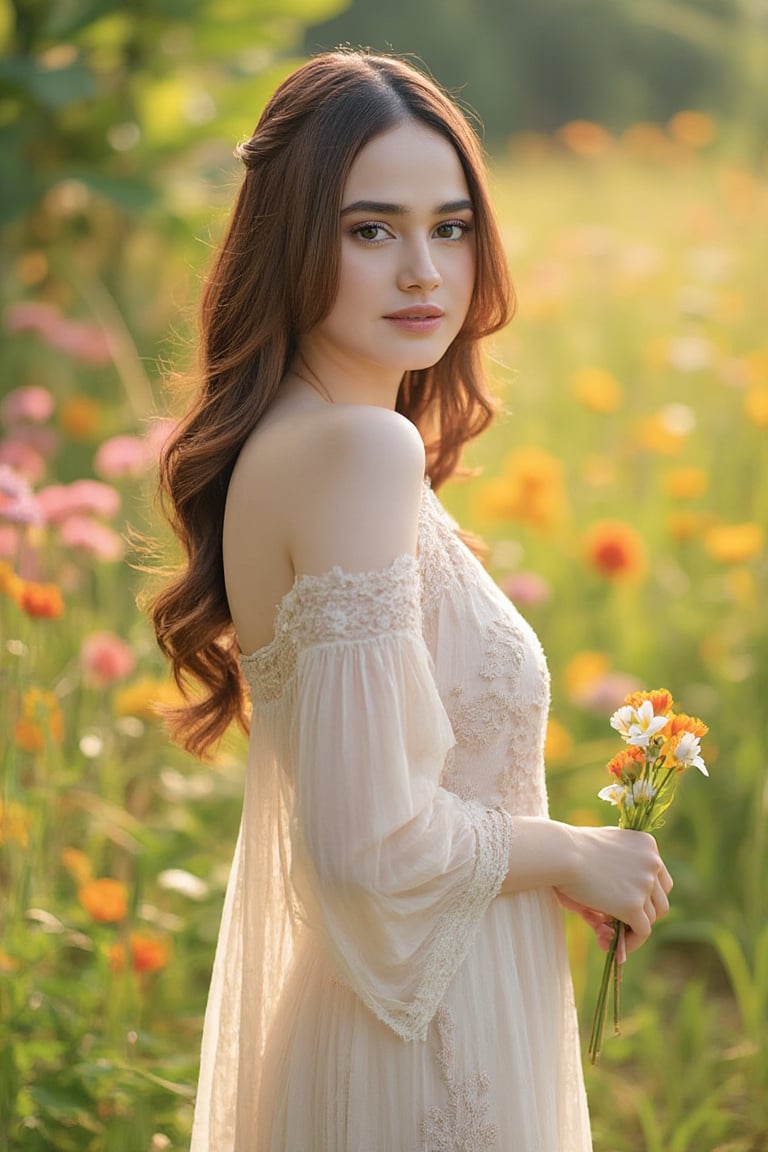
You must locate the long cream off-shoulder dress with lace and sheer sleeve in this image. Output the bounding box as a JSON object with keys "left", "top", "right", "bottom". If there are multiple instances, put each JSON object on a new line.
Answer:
{"left": 192, "top": 485, "right": 591, "bottom": 1152}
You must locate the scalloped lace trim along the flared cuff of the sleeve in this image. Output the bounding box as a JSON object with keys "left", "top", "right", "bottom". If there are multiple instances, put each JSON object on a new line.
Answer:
{"left": 358, "top": 802, "right": 512, "bottom": 1040}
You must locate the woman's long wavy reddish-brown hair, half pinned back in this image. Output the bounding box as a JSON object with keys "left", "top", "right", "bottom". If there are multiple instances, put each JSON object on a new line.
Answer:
{"left": 151, "top": 51, "right": 514, "bottom": 756}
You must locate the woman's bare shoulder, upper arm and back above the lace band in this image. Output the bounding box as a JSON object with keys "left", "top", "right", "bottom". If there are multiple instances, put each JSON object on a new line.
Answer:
{"left": 223, "top": 404, "right": 425, "bottom": 651}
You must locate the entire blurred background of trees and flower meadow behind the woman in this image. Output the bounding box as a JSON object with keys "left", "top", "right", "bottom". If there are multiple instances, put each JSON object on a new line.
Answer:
{"left": 0, "top": 0, "right": 768, "bottom": 1152}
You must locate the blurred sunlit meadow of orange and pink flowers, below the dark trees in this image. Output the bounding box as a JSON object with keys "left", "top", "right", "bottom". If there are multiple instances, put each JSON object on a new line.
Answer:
{"left": 0, "top": 113, "right": 768, "bottom": 1152}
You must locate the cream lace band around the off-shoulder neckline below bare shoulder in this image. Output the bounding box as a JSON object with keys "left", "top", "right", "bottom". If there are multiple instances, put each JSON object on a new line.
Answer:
{"left": 239, "top": 555, "right": 421, "bottom": 703}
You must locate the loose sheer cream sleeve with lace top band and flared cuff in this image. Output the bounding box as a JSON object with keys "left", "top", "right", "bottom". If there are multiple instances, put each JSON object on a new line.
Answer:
{"left": 285, "top": 555, "right": 511, "bottom": 1040}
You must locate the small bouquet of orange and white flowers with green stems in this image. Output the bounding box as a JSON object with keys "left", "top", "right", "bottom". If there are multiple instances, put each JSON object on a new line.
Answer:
{"left": 590, "top": 688, "right": 709, "bottom": 1063}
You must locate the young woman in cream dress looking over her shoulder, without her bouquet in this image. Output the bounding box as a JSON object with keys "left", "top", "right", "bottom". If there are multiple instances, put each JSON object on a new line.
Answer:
{"left": 154, "top": 52, "right": 671, "bottom": 1152}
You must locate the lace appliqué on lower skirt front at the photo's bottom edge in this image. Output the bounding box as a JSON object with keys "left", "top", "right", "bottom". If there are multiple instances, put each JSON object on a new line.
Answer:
{"left": 421, "top": 1006, "right": 499, "bottom": 1152}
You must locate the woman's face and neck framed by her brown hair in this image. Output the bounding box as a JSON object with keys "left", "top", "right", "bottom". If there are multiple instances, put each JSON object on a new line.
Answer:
{"left": 299, "top": 120, "right": 474, "bottom": 394}
